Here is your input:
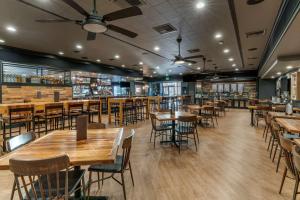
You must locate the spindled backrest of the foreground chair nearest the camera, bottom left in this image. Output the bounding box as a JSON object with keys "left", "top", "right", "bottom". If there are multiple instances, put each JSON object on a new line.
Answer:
{"left": 9, "top": 155, "right": 70, "bottom": 199}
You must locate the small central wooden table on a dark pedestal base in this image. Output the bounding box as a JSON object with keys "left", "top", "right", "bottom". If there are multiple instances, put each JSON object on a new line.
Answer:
{"left": 153, "top": 111, "right": 196, "bottom": 146}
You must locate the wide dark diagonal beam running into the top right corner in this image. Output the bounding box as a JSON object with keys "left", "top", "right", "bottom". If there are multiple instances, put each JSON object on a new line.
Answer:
{"left": 258, "top": 0, "right": 300, "bottom": 76}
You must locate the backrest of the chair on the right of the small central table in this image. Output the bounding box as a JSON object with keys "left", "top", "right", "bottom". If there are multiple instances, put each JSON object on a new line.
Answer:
{"left": 177, "top": 116, "right": 197, "bottom": 134}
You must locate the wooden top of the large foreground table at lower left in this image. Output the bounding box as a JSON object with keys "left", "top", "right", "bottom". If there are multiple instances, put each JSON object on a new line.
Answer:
{"left": 0, "top": 128, "right": 123, "bottom": 170}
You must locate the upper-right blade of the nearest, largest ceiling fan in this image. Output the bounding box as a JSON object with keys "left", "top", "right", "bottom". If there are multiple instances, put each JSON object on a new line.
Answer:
{"left": 103, "top": 6, "right": 143, "bottom": 21}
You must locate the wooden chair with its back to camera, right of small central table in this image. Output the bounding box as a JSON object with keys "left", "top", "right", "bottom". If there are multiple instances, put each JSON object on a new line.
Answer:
{"left": 175, "top": 116, "right": 198, "bottom": 153}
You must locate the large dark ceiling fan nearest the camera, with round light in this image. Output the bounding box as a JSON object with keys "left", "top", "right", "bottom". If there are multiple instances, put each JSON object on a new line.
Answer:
{"left": 18, "top": 0, "right": 143, "bottom": 40}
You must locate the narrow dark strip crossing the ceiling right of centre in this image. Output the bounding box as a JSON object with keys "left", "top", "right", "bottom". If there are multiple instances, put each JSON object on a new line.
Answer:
{"left": 228, "top": 0, "right": 245, "bottom": 68}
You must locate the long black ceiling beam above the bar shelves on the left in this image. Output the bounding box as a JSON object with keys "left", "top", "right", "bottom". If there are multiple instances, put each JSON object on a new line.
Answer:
{"left": 0, "top": 45, "right": 142, "bottom": 77}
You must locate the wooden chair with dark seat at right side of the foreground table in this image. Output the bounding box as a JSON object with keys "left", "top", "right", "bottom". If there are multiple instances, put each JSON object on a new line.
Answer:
{"left": 88, "top": 129, "right": 135, "bottom": 200}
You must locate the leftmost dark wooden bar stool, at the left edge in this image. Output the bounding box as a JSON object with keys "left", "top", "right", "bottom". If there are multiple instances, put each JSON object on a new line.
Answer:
{"left": 3, "top": 104, "right": 34, "bottom": 151}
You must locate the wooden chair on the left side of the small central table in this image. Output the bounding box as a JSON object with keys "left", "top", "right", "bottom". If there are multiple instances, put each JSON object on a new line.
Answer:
{"left": 150, "top": 113, "right": 172, "bottom": 148}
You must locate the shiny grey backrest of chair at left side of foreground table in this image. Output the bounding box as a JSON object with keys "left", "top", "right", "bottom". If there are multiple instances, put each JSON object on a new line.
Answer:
{"left": 6, "top": 132, "right": 35, "bottom": 152}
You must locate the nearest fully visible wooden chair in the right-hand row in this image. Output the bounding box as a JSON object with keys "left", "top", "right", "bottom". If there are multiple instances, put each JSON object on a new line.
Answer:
{"left": 279, "top": 136, "right": 296, "bottom": 194}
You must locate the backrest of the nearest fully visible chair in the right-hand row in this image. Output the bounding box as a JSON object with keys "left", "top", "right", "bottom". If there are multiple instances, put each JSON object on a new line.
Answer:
{"left": 279, "top": 135, "right": 295, "bottom": 175}
